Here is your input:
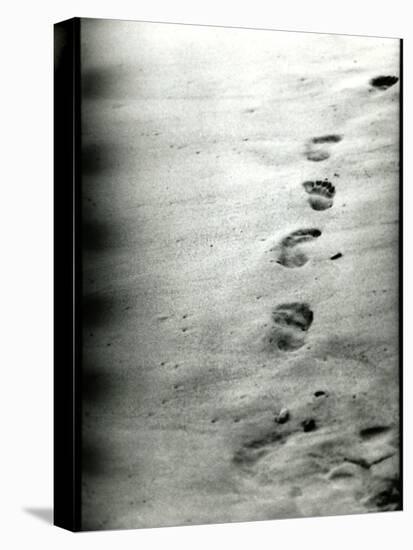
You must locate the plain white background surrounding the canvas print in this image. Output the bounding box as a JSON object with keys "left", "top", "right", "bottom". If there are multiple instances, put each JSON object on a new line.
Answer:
{"left": 0, "top": 0, "right": 413, "bottom": 550}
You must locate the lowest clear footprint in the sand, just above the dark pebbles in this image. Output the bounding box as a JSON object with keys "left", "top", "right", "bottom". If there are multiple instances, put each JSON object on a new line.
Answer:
{"left": 269, "top": 302, "right": 314, "bottom": 351}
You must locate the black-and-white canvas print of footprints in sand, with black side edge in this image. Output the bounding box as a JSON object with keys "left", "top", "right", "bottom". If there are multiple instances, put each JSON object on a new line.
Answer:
{"left": 55, "top": 19, "right": 402, "bottom": 530}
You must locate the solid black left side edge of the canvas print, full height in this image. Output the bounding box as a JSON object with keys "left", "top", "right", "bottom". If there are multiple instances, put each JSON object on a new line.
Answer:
{"left": 53, "top": 18, "right": 82, "bottom": 531}
